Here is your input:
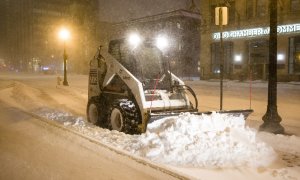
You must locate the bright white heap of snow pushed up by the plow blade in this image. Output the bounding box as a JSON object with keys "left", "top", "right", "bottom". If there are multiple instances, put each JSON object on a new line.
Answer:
{"left": 125, "top": 113, "right": 276, "bottom": 167}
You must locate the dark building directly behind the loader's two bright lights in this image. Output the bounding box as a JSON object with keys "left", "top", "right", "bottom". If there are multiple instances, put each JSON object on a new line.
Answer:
{"left": 110, "top": 10, "right": 201, "bottom": 79}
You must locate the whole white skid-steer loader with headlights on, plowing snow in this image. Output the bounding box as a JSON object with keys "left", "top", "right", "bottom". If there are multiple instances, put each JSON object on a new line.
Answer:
{"left": 87, "top": 34, "right": 252, "bottom": 134}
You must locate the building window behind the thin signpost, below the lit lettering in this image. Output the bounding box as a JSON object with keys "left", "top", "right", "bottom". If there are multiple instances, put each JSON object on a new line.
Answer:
{"left": 211, "top": 42, "right": 233, "bottom": 74}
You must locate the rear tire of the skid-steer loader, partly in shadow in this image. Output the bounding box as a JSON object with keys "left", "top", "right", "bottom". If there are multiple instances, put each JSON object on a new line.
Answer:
{"left": 87, "top": 98, "right": 107, "bottom": 128}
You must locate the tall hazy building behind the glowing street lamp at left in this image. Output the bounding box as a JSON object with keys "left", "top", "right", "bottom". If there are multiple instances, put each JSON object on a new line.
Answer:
{"left": 0, "top": 0, "right": 98, "bottom": 72}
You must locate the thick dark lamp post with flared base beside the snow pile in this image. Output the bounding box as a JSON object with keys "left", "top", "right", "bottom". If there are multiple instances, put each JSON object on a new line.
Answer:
{"left": 259, "top": 0, "right": 284, "bottom": 134}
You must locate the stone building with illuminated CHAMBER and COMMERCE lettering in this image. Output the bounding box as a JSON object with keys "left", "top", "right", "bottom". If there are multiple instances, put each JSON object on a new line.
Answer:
{"left": 200, "top": 0, "right": 300, "bottom": 81}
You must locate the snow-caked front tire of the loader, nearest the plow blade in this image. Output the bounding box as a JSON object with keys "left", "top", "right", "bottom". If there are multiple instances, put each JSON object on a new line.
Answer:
{"left": 108, "top": 99, "right": 141, "bottom": 134}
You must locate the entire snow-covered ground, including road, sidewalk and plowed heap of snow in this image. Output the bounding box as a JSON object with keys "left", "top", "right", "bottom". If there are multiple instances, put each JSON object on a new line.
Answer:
{"left": 0, "top": 74, "right": 300, "bottom": 179}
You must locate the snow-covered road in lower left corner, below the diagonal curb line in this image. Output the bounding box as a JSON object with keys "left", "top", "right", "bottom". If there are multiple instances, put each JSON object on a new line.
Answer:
{"left": 0, "top": 101, "right": 186, "bottom": 180}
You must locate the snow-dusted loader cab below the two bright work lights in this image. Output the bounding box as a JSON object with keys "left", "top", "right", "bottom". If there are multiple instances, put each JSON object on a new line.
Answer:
{"left": 108, "top": 38, "right": 171, "bottom": 90}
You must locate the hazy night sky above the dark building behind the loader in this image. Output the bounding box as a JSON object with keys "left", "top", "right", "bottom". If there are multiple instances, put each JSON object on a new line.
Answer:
{"left": 99, "top": 0, "right": 199, "bottom": 22}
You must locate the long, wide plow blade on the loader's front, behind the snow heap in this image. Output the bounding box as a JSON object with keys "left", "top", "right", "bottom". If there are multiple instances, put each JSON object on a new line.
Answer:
{"left": 149, "top": 109, "right": 253, "bottom": 123}
